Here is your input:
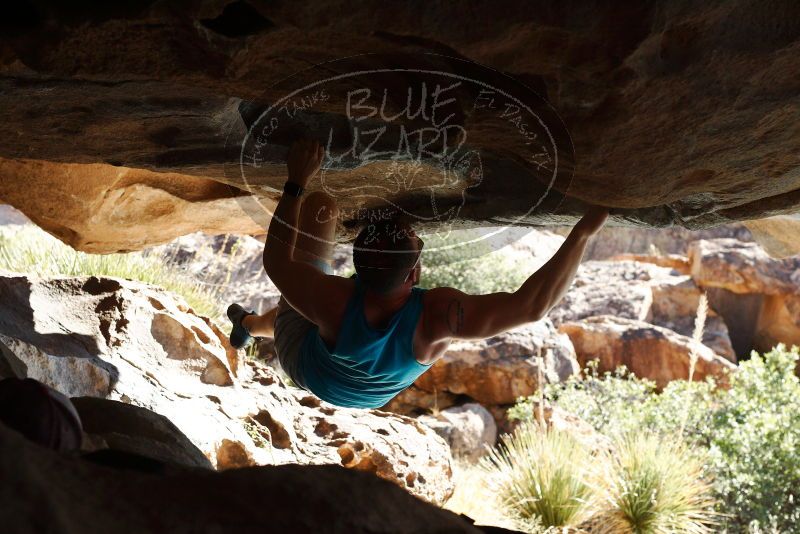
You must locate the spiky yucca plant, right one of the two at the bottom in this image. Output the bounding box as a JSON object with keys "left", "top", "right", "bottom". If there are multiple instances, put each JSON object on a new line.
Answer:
{"left": 591, "top": 433, "right": 717, "bottom": 534}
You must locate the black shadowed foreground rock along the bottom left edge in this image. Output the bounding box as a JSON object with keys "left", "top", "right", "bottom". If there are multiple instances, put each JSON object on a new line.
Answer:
{"left": 0, "top": 425, "right": 494, "bottom": 534}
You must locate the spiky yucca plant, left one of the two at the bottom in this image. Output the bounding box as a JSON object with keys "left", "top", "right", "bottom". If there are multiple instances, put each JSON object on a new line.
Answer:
{"left": 481, "top": 428, "right": 597, "bottom": 528}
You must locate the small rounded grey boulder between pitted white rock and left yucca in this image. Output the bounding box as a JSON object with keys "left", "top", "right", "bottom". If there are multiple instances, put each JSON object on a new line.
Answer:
{"left": 417, "top": 402, "right": 497, "bottom": 462}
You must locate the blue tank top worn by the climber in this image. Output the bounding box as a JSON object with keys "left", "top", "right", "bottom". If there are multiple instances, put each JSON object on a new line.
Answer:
{"left": 300, "top": 276, "right": 430, "bottom": 408}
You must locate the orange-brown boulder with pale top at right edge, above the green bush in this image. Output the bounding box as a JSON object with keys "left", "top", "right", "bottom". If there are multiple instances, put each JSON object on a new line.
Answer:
{"left": 689, "top": 239, "right": 800, "bottom": 358}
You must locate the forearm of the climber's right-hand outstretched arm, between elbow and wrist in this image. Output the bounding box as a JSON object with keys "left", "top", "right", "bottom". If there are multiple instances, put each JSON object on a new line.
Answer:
{"left": 515, "top": 227, "right": 591, "bottom": 320}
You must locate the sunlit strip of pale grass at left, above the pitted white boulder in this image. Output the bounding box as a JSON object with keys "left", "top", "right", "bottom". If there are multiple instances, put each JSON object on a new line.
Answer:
{"left": 0, "top": 226, "right": 222, "bottom": 319}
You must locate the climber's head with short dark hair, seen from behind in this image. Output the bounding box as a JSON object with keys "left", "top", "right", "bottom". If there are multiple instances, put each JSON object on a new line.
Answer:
{"left": 353, "top": 219, "right": 419, "bottom": 293}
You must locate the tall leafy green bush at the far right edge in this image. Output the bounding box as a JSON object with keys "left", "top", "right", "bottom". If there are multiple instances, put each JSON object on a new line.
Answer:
{"left": 708, "top": 346, "right": 800, "bottom": 532}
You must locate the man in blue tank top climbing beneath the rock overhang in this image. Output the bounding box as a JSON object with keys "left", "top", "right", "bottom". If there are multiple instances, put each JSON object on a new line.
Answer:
{"left": 228, "top": 141, "right": 608, "bottom": 408}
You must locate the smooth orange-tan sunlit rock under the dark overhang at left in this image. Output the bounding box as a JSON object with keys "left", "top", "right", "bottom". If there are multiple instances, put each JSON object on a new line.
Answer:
{"left": 0, "top": 158, "right": 268, "bottom": 253}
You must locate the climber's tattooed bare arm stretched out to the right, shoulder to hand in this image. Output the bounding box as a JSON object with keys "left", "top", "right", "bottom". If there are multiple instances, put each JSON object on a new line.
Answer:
{"left": 430, "top": 206, "right": 608, "bottom": 340}
